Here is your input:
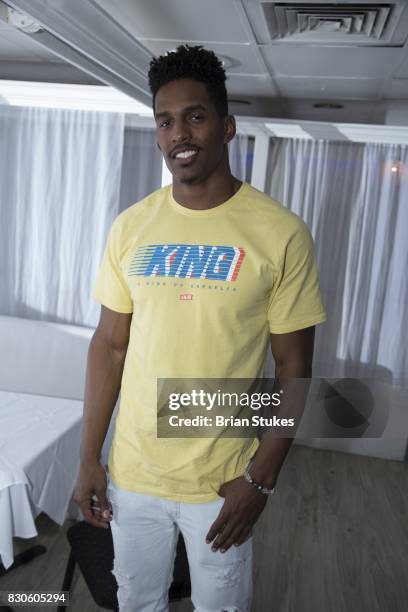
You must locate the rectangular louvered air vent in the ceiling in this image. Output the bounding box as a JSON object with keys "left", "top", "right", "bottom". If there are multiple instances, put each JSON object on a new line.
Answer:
{"left": 261, "top": 2, "right": 407, "bottom": 46}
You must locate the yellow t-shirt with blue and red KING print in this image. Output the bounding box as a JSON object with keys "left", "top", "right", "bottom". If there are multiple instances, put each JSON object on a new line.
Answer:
{"left": 93, "top": 183, "right": 326, "bottom": 503}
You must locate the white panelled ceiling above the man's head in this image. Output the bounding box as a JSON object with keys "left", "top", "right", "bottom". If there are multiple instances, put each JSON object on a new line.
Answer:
{"left": 0, "top": 0, "right": 408, "bottom": 125}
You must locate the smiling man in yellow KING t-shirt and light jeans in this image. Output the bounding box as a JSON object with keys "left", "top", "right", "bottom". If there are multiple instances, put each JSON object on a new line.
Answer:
{"left": 76, "top": 46, "right": 325, "bottom": 612}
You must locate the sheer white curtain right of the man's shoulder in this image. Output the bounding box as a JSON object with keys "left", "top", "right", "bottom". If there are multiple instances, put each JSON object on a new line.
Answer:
{"left": 268, "top": 139, "right": 408, "bottom": 386}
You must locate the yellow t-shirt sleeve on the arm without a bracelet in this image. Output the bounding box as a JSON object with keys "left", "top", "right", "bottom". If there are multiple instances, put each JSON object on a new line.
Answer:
{"left": 92, "top": 218, "right": 133, "bottom": 313}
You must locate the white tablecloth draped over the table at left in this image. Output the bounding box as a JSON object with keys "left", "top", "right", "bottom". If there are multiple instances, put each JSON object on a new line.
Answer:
{"left": 0, "top": 391, "right": 83, "bottom": 568}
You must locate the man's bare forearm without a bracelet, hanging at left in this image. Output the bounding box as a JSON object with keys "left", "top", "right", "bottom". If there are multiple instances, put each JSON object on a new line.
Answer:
{"left": 81, "top": 333, "right": 126, "bottom": 464}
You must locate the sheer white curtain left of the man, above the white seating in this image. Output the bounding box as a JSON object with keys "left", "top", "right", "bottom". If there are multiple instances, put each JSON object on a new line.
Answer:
{"left": 0, "top": 105, "right": 124, "bottom": 325}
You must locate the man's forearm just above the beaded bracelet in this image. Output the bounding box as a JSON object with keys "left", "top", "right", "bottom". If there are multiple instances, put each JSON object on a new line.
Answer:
{"left": 250, "top": 363, "right": 312, "bottom": 489}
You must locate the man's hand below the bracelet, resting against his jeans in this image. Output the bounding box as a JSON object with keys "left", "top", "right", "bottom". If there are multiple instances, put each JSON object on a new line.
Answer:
{"left": 206, "top": 476, "right": 268, "bottom": 552}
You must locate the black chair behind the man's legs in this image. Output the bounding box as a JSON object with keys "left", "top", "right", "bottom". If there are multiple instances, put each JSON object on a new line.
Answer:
{"left": 57, "top": 521, "right": 191, "bottom": 612}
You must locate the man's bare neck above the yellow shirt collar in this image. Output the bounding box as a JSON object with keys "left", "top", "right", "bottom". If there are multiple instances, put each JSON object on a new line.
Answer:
{"left": 173, "top": 161, "right": 242, "bottom": 210}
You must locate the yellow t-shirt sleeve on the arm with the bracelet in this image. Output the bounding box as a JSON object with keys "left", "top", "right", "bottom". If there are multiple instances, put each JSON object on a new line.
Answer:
{"left": 268, "top": 218, "right": 326, "bottom": 334}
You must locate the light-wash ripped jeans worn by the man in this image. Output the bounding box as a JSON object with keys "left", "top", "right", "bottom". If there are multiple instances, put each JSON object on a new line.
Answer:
{"left": 107, "top": 479, "right": 252, "bottom": 612}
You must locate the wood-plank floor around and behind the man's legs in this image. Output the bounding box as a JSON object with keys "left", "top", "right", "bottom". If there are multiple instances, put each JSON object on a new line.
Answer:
{"left": 0, "top": 446, "right": 408, "bottom": 612}
